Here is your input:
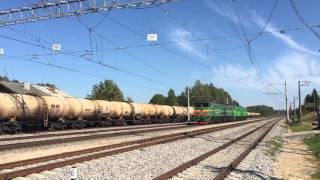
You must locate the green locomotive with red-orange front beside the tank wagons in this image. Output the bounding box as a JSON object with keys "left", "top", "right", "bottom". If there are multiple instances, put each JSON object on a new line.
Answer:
{"left": 191, "top": 102, "right": 248, "bottom": 124}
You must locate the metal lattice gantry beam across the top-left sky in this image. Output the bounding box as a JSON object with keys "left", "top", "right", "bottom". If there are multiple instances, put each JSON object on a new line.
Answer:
{"left": 0, "top": 0, "right": 177, "bottom": 27}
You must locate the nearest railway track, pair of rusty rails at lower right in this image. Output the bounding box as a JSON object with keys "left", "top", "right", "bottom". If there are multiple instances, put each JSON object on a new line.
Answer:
{"left": 154, "top": 120, "right": 279, "bottom": 180}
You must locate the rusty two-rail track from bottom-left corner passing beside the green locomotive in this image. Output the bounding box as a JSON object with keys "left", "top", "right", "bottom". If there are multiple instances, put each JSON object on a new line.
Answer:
{"left": 0, "top": 120, "right": 270, "bottom": 180}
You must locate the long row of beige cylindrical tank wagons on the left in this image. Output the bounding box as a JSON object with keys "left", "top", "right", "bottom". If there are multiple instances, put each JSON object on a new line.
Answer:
{"left": 0, "top": 93, "right": 192, "bottom": 133}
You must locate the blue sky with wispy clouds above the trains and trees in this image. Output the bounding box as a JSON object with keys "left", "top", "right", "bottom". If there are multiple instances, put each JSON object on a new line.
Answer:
{"left": 0, "top": 0, "right": 320, "bottom": 108}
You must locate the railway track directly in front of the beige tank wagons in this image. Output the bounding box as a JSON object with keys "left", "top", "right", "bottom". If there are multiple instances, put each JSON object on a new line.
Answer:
{"left": 0, "top": 123, "right": 185, "bottom": 142}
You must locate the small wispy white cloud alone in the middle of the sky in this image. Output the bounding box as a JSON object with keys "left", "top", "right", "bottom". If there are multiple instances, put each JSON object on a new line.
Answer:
{"left": 170, "top": 29, "right": 206, "bottom": 59}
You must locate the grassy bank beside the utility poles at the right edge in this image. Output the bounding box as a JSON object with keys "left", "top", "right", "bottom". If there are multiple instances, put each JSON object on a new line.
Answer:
{"left": 290, "top": 112, "right": 315, "bottom": 132}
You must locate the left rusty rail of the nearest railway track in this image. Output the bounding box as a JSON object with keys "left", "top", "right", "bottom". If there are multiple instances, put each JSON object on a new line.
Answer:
{"left": 154, "top": 120, "right": 278, "bottom": 180}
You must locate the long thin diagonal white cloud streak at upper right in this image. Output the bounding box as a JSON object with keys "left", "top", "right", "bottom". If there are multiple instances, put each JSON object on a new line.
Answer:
{"left": 252, "top": 12, "right": 317, "bottom": 55}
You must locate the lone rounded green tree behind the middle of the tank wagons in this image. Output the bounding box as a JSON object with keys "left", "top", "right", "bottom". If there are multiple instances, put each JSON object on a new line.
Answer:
{"left": 88, "top": 80, "right": 124, "bottom": 101}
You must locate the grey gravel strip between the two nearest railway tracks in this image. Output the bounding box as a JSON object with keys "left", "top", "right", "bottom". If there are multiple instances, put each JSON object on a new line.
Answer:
{"left": 13, "top": 119, "right": 272, "bottom": 179}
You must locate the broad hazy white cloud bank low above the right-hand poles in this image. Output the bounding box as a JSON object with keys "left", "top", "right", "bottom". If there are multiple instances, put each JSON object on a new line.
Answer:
{"left": 213, "top": 52, "right": 320, "bottom": 93}
